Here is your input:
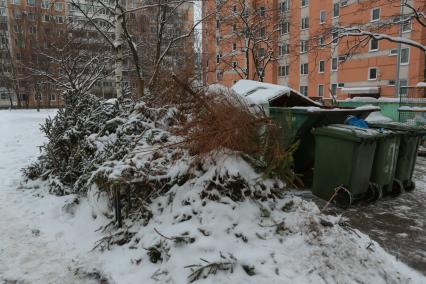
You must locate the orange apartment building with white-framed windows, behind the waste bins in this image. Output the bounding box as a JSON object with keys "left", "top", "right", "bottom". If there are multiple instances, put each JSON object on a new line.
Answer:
{"left": 202, "top": 0, "right": 426, "bottom": 99}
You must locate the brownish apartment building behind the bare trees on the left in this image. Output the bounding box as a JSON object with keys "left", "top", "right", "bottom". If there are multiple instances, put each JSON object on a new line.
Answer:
{"left": 0, "top": 0, "right": 195, "bottom": 107}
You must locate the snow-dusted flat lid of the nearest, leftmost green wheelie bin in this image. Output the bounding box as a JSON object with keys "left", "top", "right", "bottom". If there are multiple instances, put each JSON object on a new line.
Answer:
{"left": 314, "top": 124, "right": 391, "bottom": 142}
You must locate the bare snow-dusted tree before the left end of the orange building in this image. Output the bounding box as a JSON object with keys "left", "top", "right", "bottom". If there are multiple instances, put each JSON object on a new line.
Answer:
{"left": 209, "top": 0, "right": 288, "bottom": 81}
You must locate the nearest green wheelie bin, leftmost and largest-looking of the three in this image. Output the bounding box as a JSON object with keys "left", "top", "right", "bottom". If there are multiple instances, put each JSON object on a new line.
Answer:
{"left": 312, "top": 124, "right": 384, "bottom": 208}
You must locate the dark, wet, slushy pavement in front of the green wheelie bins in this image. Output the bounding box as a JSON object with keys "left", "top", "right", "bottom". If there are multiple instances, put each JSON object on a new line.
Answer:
{"left": 301, "top": 157, "right": 426, "bottom": 275}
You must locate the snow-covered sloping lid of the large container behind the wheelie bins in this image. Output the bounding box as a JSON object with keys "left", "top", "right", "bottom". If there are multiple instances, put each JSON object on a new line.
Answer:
{"left": 232, "top": 80, "right": 320, "bottom": 106}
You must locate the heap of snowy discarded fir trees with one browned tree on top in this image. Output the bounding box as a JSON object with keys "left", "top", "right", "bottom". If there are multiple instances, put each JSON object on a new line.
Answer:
{"left": 24, "top": 85, "right": 292, "bottom": 217}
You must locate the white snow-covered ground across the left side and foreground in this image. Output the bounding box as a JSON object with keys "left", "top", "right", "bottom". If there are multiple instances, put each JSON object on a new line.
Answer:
{"left": 0, "top": 111, "right": 426, "bottom": 283}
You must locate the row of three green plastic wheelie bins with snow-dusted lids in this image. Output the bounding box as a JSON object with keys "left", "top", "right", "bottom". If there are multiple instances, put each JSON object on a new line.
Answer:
{"left": 313, "top": 122, "right": 426, "bottom": 208}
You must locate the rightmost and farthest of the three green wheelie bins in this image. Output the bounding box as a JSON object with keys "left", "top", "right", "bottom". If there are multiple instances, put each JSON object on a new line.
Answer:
{"left": 369, "top": 122, "right": 426, "bottom": 191}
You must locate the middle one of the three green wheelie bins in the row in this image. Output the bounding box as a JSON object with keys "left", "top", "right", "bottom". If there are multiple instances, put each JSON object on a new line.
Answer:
{"left": 368, "top": 129, "right": 403, "bottom": 201}
